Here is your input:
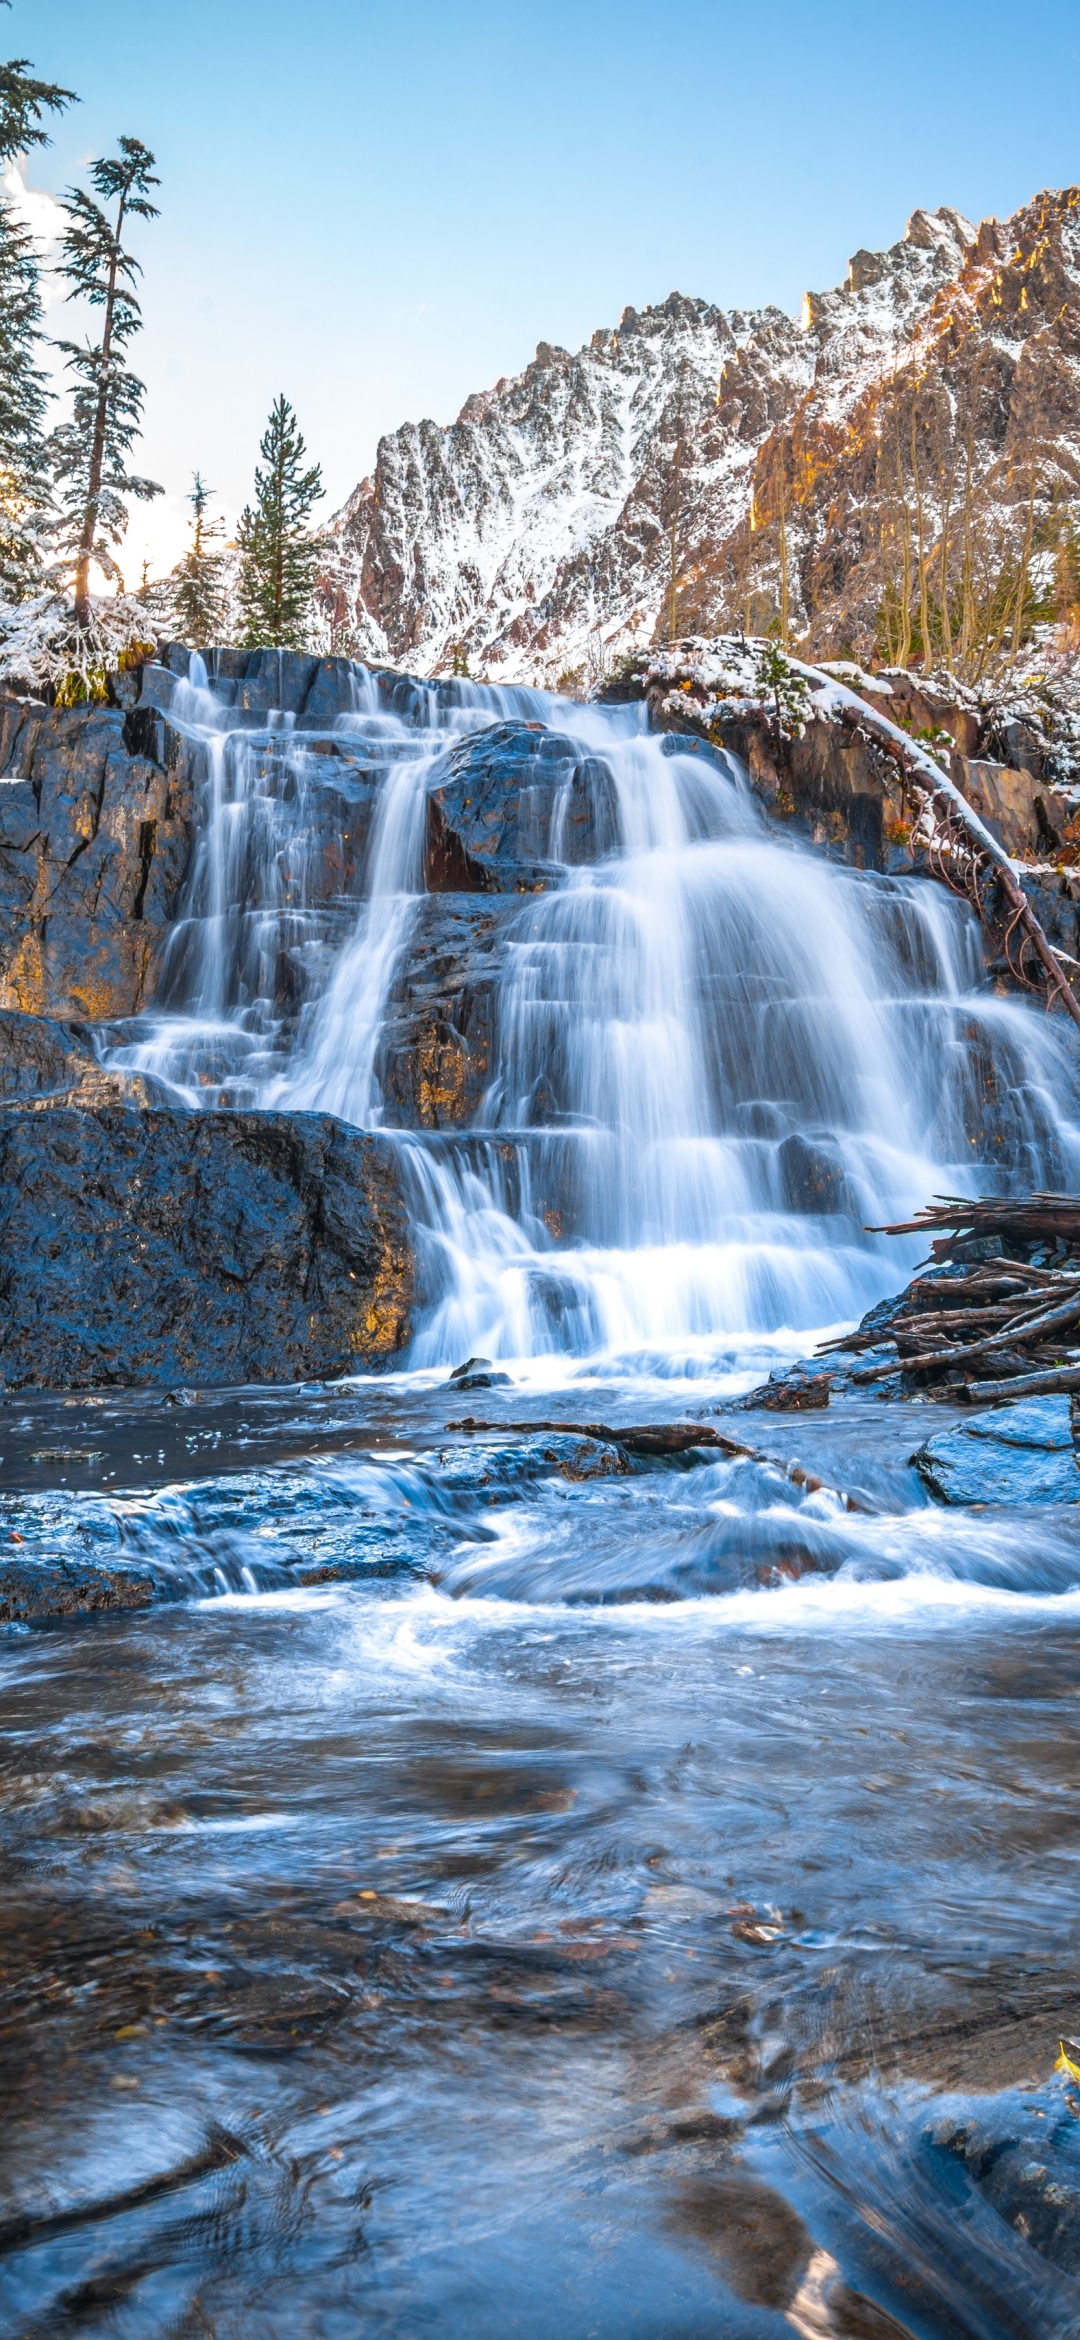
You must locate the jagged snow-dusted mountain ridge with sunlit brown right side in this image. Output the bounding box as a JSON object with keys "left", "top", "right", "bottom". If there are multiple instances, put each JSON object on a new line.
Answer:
{"left": 323, "top": 187, "right": 1080, "bottom": 688}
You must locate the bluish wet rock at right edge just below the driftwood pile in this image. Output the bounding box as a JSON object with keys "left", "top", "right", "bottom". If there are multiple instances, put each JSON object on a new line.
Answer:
{"left": 912, "top": 1397, "right": 1080, "bottom": 1505}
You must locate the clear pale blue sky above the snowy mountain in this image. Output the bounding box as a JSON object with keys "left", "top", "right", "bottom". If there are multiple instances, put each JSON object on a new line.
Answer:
{"left": 21, "top": 0, "right": 1080, "bottom": 576}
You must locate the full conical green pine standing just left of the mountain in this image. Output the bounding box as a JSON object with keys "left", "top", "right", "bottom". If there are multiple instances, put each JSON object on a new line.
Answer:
{"left": 238, "top": 398, "right": 323, "bottom": 651}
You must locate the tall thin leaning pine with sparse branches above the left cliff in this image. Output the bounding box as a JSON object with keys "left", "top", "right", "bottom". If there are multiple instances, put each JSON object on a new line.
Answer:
{"left": 51, "top": 138, "right": 161, "bottom": 629}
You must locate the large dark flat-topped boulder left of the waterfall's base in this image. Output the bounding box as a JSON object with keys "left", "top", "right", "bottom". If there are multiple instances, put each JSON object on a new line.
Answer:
{"left": 0, "top": 1107, "right": 414, "bottom": 1388}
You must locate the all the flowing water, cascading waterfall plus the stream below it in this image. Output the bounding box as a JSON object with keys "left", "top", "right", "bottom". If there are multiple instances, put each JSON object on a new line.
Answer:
{"left": 0, "top": 660, "right": 1080, "bottom": 2340}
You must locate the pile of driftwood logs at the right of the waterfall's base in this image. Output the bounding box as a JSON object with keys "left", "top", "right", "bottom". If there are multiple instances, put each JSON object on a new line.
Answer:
{"left": 823, "top": 1193, "right": 1080, "bottom": 1404}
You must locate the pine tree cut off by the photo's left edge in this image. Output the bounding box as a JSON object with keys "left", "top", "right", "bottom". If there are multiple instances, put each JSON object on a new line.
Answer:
{"left": 0, "top": 33, "right": 75, "bottom": 601}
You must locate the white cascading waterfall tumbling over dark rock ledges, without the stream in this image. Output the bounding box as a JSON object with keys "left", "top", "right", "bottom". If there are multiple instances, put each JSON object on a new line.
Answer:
{"left": 112, "top": 662, "right": 1080, "bottom": 1374}
